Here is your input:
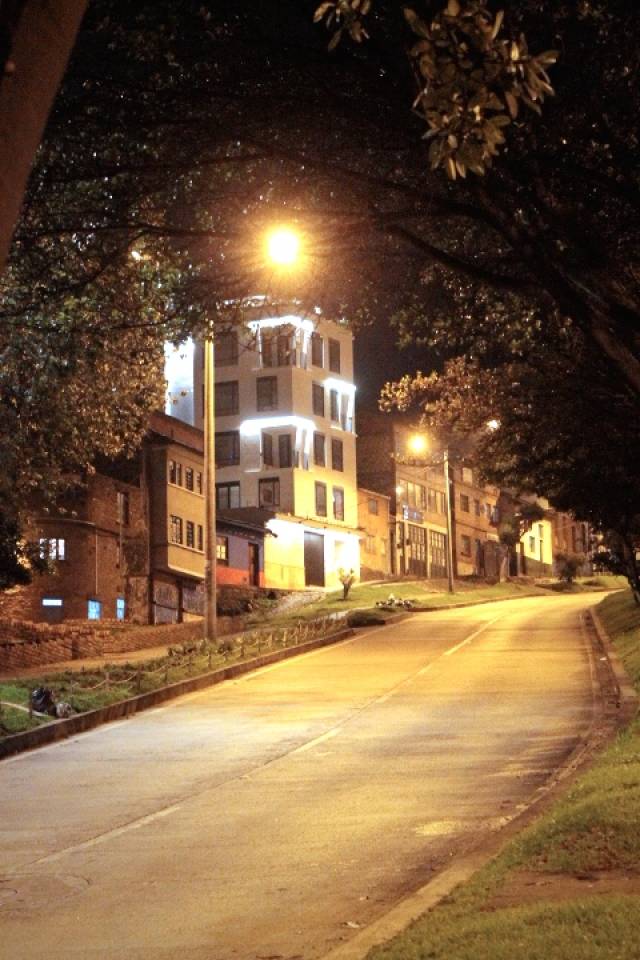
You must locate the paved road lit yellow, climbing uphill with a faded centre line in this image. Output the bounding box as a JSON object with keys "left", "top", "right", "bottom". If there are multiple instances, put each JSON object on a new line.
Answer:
{"left": 0, "top": 594, "right": 593, "bottom": 960}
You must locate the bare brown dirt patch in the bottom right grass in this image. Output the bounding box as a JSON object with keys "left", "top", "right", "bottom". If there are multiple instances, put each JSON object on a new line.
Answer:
{"left": 484, "top": 870, "right": 640, "bottom": 910}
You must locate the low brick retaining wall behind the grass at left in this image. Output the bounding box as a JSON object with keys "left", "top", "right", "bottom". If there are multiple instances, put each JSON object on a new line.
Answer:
{"left": 0, "top": 617, "right": 245, "bottom": 671}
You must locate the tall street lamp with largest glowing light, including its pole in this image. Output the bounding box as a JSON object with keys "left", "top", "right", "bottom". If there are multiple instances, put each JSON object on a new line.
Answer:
{"left": 204, "top": 226, "right": 301, "bottom": 643}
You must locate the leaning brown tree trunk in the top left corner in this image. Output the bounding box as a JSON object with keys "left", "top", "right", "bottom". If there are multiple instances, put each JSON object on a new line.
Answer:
{"left": 0, "top": 0, "right": 87, "bottom": 271}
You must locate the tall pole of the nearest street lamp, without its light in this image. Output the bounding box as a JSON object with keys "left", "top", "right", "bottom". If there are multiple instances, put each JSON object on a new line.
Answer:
{"left": 203, "top": 336, "right": 218, "bottom": 643}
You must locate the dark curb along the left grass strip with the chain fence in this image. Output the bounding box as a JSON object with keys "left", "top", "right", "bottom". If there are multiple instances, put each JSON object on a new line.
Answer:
{"left": 0, "top": 627, "right": 354, "bottom": 760}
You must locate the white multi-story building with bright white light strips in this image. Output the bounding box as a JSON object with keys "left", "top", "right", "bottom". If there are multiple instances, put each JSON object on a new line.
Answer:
{"left": 166, "top": 304, "right": 360, "bottom": 588}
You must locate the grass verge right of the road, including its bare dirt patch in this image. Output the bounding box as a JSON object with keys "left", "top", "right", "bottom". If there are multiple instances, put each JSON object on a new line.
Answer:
{"left": 369, "top": 591, "right": 640, "bottom": 960}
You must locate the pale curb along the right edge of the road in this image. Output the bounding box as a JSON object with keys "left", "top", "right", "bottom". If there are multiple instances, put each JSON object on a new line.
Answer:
{"left": 321, "top": 595, "right": 640, "bottom": 960}
